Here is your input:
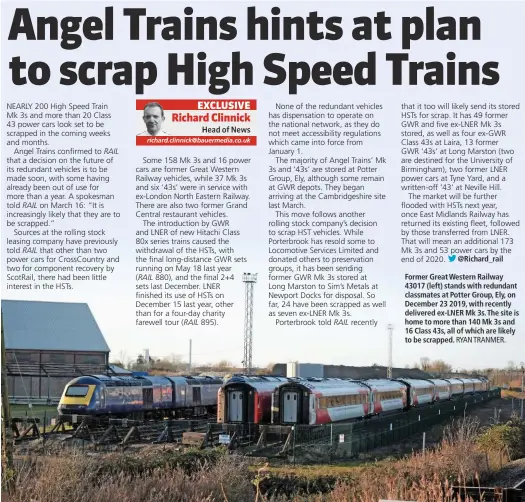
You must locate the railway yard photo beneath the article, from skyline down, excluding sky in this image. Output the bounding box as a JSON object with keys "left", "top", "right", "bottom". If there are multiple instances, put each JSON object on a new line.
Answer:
{"left": 2, "top": 300, "right": 525, "bottom": 502}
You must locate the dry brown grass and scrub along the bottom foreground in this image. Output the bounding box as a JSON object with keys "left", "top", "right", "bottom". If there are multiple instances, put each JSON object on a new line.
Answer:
{"left": 2, "top": 417, "right": 525, "bottom": 502}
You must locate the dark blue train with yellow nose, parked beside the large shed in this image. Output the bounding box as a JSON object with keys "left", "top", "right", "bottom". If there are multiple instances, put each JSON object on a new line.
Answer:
{"left": 58, "top": 375, "right": 224, "bottom": 420}
